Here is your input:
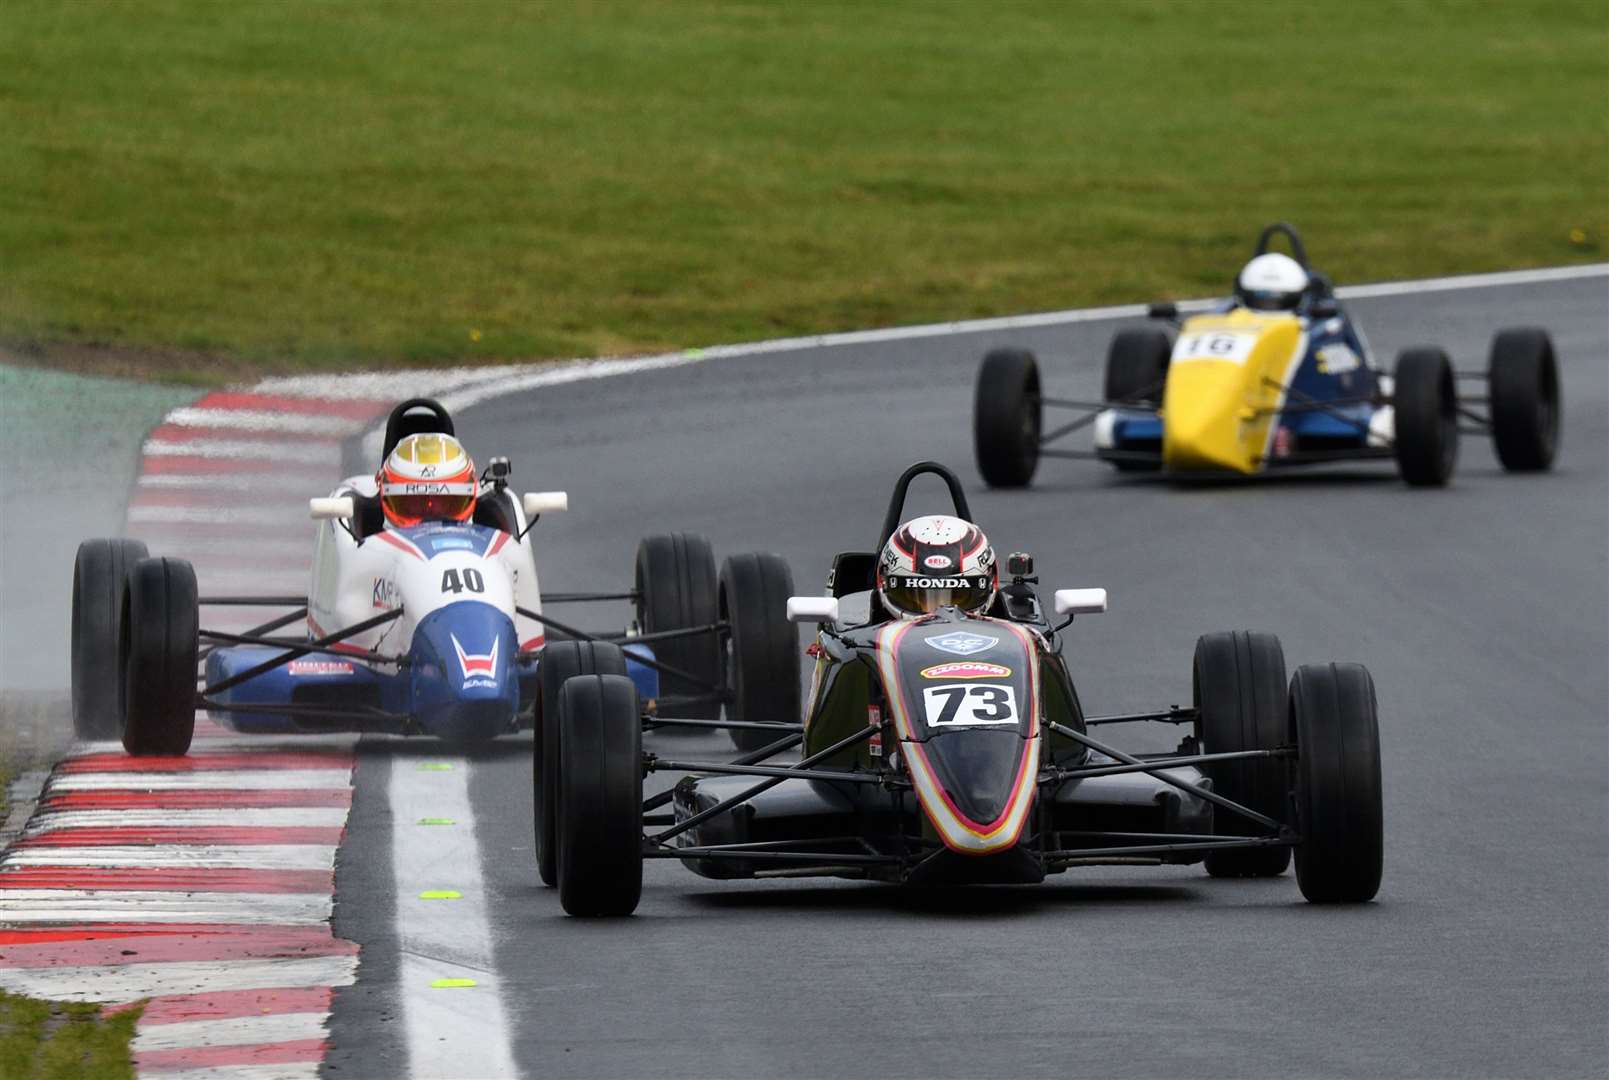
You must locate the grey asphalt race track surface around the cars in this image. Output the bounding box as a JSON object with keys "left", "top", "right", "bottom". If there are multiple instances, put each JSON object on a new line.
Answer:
{"left": 327, "top": 278, "right": 1609, "bottom": 1077}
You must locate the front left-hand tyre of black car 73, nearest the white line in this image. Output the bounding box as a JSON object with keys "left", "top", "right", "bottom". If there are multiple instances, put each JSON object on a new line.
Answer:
{"left": 558, "top": 674, "right": 642, "bottom": 916}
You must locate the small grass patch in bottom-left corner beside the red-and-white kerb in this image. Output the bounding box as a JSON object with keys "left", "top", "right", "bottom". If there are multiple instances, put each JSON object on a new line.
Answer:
{"left": 0, "top": 990, "right": 140, "bottom": 1080}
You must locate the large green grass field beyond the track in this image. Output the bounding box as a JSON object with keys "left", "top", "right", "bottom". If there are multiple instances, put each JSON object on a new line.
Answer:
{"left": 0, "top": 0, "right": 1609, "bottom": 376}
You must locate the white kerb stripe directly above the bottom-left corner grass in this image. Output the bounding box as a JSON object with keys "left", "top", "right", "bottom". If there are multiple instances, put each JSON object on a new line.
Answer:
{"left": 0, "top": 956, "right": 355, "bottom": 1004}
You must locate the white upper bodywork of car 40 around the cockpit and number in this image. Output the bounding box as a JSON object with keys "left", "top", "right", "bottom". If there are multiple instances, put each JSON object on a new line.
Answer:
{"left": 307, "top": 476, "right": 562, "bottom": 655}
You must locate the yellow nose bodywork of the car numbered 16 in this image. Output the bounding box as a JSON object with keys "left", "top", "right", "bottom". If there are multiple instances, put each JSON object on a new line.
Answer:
{"left": 1162, "top": 309, "right": 1307, "bottom": 473}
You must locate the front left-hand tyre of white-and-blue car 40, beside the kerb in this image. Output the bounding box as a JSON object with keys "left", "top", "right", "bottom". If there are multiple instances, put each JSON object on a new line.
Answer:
{"left": 117, "top": 559, "right": 201, "bottom": 756}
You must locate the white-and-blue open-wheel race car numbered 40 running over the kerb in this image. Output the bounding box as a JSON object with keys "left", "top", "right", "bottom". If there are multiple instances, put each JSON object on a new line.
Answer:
{"left": 72, "top": 399, "right": 798, "bottom": 755}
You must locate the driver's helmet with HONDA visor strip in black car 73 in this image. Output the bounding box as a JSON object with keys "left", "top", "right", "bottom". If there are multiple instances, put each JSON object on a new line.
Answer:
{"left": 877, "top": 513, "right": 999, "bottom": 618}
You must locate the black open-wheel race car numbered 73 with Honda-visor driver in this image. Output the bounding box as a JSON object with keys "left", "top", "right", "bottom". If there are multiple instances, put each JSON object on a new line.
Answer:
{"left": 537, "top": 462, "right": 1384, "bottom": 914}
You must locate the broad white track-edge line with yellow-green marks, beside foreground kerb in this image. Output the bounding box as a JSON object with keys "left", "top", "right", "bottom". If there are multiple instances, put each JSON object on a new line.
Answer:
{"left": 389, "top": 758, "right": 516, "bottom": 1077}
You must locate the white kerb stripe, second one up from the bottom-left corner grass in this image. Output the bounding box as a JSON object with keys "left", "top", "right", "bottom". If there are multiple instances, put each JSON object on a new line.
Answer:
{"left": 0, "top": 888, "right": 335, "bottom": 925}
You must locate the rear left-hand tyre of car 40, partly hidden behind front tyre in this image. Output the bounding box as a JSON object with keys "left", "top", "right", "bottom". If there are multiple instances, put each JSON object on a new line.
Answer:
{"left": 72, "top": 539, "right": 150, "bottom": 739}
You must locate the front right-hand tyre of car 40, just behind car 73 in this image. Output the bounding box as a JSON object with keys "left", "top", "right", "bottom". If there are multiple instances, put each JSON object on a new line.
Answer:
{"left": 721, "top": 552, "right": 800, "bottom": 753}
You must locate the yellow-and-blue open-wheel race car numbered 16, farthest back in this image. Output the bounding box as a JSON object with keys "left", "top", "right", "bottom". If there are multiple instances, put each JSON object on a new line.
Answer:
{"left": 972, "top": 222, "right": 1559, "bottom": 488}
